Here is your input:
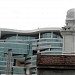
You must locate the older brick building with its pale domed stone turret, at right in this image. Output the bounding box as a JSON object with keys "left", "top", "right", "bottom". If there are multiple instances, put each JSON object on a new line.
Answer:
{"left": 37, "top": 9, "right": 75, "bottom": 75}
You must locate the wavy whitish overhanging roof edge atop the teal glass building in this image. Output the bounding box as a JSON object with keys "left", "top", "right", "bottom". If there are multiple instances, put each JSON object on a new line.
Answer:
{"left": 0, "top": 28, "right": 61, "bottom": 35}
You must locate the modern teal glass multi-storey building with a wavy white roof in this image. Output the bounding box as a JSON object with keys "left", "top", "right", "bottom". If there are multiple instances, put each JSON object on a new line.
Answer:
{"left": 0, "top": 28, "right": 63, "bottom": 75}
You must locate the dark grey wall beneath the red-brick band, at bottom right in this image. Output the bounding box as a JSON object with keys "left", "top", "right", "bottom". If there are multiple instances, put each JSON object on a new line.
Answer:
{"left": 38, "top": 69, "right": 75, "bottom": 75}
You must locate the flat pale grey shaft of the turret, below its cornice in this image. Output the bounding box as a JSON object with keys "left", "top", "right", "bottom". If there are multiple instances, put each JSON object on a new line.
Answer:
{"left": 63, "top": 32, "right": 74, "bottom": 54}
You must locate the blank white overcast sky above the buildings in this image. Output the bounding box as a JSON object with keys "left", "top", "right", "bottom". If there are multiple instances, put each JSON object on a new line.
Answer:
{"left": 0, "top": 0, "right": 75, "bottom": 30}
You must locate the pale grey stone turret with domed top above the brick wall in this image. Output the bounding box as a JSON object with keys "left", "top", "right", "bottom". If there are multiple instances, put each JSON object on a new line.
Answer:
{"left": 61, "top": 8, "right": 75, "bottom": 54}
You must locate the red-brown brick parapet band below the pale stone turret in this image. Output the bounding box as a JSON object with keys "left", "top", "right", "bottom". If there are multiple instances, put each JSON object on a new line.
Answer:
{"left": 37, "top": 55, "right": 75, "bottom": 69}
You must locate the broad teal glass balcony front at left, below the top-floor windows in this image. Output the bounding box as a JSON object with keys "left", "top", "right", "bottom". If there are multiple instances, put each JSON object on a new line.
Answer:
{"left": 0, "top": 42, "right": 28, "bottom": 54}
